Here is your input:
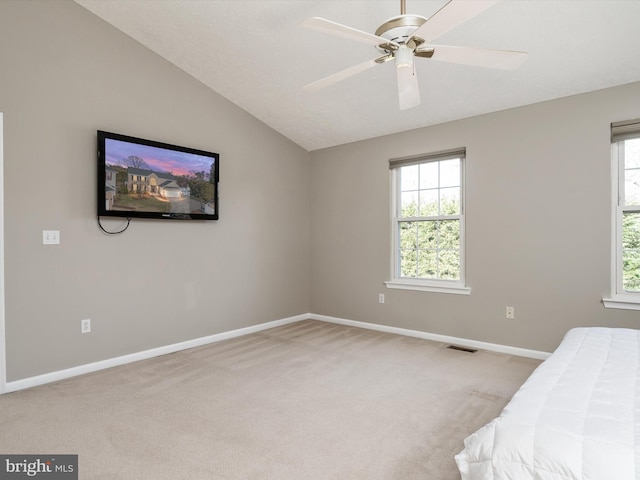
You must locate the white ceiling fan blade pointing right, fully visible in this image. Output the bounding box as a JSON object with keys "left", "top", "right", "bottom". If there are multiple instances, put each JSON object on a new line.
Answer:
{"left": 429, "top": 45, "right": 527, "bottom": 70}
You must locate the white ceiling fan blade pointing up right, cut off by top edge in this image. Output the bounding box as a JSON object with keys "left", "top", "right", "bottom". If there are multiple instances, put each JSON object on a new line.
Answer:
{"left": 412, "top": 0, "right": 500, "bottom": 43}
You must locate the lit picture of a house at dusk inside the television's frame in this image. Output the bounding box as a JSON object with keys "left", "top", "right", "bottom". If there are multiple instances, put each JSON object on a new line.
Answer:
{"left": 105, "top": 139, "right": 216, "bottom": 214}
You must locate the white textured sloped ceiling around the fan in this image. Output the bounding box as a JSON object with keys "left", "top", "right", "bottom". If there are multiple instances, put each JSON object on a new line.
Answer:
{"left": 75, "top": 0, "right": 640, "bottom": 151}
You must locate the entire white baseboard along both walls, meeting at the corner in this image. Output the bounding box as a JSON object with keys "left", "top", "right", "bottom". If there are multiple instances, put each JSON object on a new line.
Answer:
{"left": 0, "top": 313, "right": 550, "bottom": 393}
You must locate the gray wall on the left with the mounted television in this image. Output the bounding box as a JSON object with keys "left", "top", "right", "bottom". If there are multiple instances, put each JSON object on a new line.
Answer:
{"left": 0, "top": 0, "right": 310, "bottom": 381}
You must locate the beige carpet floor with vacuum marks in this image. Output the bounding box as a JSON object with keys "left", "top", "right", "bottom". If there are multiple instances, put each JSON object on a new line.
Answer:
{"left": 0, "top": 320, "right": 540, "bottom": 480}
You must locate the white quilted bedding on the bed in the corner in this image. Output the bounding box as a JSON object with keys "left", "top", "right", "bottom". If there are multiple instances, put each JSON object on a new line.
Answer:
{"left": 456, "top": 328, "right": 640, "bottom": 480}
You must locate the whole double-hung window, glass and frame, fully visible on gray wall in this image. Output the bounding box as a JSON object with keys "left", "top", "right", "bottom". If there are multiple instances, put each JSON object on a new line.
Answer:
{"left": 386, "top": 149, "right": 470, "bottom": 294}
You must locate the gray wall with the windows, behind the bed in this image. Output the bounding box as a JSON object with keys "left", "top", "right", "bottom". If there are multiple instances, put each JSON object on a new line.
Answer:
{"left": 311, "top": 84, "right": 640, "bottom": 351}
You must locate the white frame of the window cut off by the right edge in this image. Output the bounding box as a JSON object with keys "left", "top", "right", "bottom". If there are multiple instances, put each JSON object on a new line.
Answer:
{"left": 602, "top": 120, "right": 640, "bottom": 310}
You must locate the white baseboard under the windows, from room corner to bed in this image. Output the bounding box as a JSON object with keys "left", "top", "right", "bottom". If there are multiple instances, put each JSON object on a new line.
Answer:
{"left": 309, "top": 313, "right": 551, "bottom": 360}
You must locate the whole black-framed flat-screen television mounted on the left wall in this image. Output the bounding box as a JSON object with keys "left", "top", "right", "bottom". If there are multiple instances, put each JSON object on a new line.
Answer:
{"left": 98, "top": 130, "right": 220, "bottom": 220}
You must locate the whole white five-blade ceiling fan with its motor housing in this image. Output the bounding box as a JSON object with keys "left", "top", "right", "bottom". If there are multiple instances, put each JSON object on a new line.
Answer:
{"left": 302, "top": 0, "right": 527, "bottom": 110}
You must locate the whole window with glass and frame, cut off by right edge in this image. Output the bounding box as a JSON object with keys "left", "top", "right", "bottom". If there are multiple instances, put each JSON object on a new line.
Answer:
{"left": 604, "top": 119, "right": 640, "bottom": 310}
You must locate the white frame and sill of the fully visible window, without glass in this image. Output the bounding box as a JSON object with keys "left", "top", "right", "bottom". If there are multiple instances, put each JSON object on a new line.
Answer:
{"left": 384, "top": 148, "right": 471, "bottom": 295}
